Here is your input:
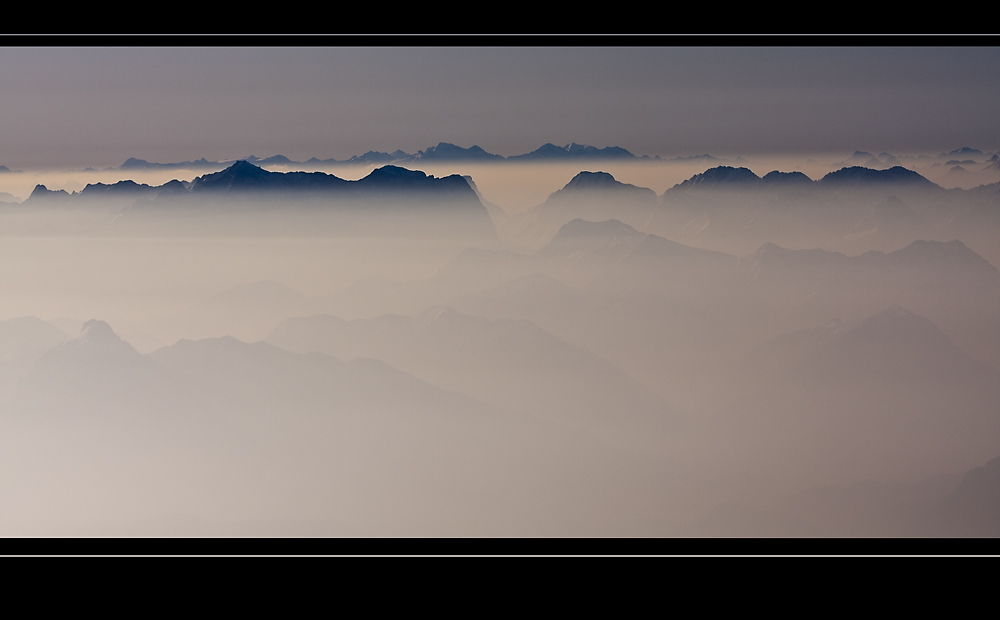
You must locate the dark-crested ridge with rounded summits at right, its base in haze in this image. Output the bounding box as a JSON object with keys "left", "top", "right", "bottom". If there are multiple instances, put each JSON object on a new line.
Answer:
{"left": 644, "top": 166, "right": 978, "bottom": 254}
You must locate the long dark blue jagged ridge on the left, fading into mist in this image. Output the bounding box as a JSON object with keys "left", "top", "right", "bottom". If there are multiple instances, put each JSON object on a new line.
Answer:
{"left": 24, "top": 161, "right": 497, "bottom": 240}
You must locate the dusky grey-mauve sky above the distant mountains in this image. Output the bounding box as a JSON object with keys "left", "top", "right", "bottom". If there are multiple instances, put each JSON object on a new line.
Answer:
{"left": 0, "top": 41, "right": 1000, "bottom": 168}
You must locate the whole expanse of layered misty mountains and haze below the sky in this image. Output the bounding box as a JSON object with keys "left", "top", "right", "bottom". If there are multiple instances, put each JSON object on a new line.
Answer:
{"left": 0, "top": 150, "right": 1000, "bottom": 537}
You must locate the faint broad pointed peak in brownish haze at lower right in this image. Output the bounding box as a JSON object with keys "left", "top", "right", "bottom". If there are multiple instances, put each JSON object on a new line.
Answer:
{"left": 730, "top": 306, "right": 1000, "bottom": 479}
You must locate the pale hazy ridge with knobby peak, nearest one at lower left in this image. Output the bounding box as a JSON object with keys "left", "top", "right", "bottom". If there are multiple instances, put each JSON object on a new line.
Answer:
{"left": 0, "top": 321, "right": 696, "bottom": 535}
